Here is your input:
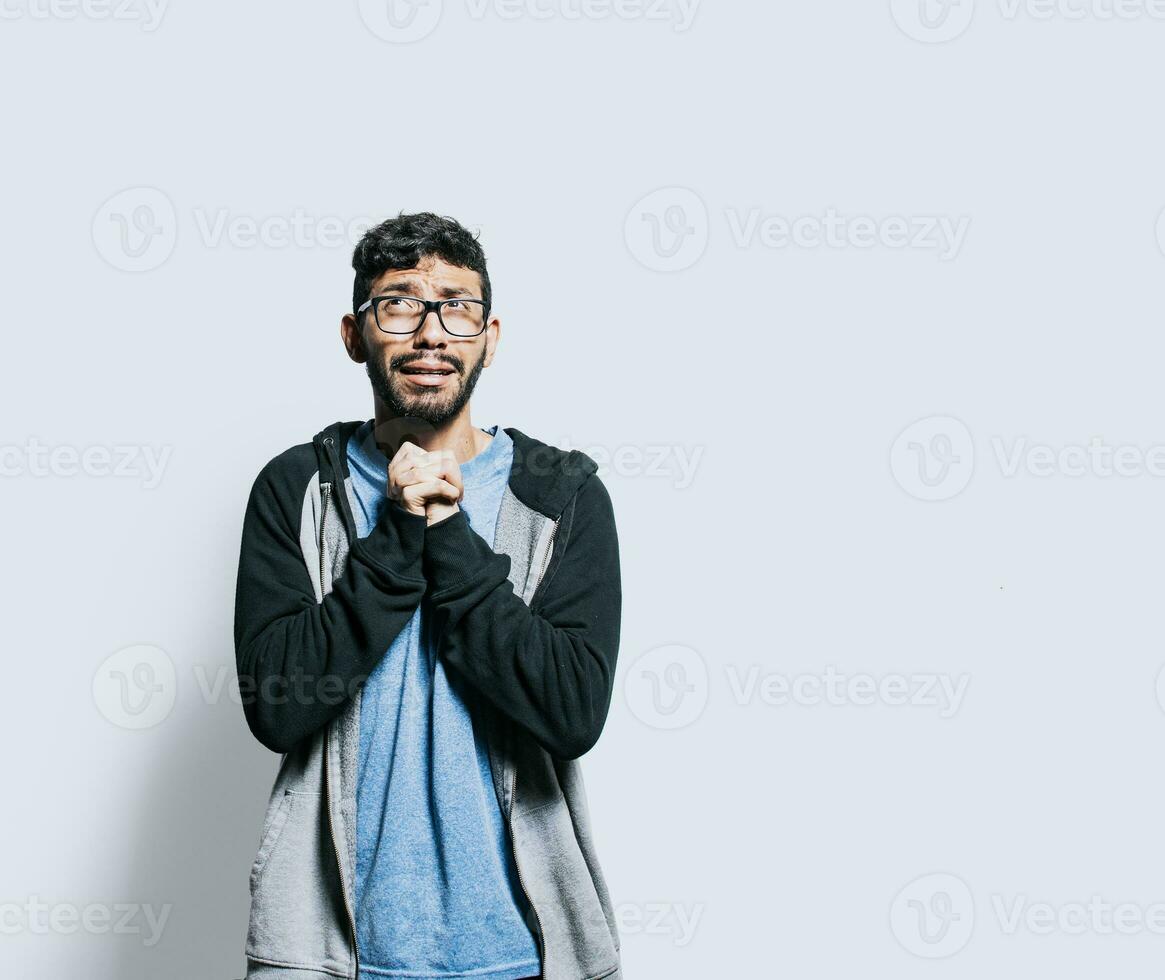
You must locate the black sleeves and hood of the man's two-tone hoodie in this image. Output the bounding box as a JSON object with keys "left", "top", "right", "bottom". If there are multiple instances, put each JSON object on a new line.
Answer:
{"left": 234, "top": 422, "right": 622, "bottom": 760}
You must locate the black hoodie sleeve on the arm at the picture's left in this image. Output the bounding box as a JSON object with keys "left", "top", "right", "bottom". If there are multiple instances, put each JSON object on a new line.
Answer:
{"left": 234, "top": 458, "right": 426, "bottom": 753}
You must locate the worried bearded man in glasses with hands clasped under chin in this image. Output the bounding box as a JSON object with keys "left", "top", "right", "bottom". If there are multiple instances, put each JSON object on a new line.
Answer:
{"left": 234, "top": 213, "right": 622, "bottom": 980}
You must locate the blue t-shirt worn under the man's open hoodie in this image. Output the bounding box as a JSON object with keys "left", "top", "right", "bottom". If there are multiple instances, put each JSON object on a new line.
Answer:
{"left": 348, "top": 421, "right": 541, "bottom": 980}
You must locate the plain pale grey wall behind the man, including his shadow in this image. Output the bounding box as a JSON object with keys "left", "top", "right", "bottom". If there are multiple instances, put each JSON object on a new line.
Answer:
{"left": 0, "top": 0, "right": 1165, "bottom": 980}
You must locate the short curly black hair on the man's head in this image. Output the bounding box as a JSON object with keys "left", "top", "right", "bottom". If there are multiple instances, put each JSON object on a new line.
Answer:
{"left": 352, "top": 211, "right": 492, "bottom": 313}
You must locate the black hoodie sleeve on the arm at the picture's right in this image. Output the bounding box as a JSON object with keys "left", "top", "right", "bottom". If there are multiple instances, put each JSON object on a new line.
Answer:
{"left": 423, "top": 473, "right": 622, "bottom": 759}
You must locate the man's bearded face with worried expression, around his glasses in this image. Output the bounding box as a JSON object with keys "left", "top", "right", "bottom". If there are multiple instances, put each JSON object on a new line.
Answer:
{"left": 340, "top": 256, "right": 501, "bottom": 425}
